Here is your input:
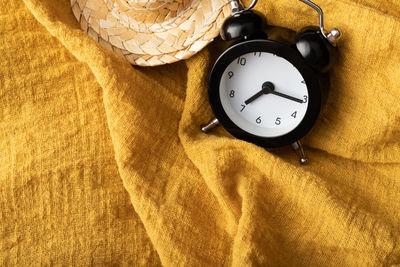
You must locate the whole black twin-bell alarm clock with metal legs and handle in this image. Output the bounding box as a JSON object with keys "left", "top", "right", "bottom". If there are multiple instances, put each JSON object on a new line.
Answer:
{"left": 201, "top": 0, "right": 340, "bottom": 163}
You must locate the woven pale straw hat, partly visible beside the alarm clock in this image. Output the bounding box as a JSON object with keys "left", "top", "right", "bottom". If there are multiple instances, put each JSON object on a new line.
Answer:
{"left": 71, "top": 0, "right": 231, "bottom": 66}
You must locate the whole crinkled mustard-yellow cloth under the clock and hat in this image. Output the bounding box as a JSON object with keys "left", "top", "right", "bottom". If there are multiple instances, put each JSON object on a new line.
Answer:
{"left": 0, "top": 0, "right": 400, "bottom": 266}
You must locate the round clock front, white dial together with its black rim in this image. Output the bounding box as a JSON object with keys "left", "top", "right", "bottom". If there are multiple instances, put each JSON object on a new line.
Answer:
{"left": 208, "top": 39, "right": 322, "bottom": 147}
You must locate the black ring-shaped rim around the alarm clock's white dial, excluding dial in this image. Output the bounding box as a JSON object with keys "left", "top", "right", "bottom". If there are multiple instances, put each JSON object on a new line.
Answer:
{"left": 208, "top": 39, "right": 321, "bottom": 148}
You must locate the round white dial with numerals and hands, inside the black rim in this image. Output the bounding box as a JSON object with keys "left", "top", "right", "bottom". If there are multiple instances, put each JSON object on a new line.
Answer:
{"left": 219, "top": 52, "right": 308, "bottom": 137}
